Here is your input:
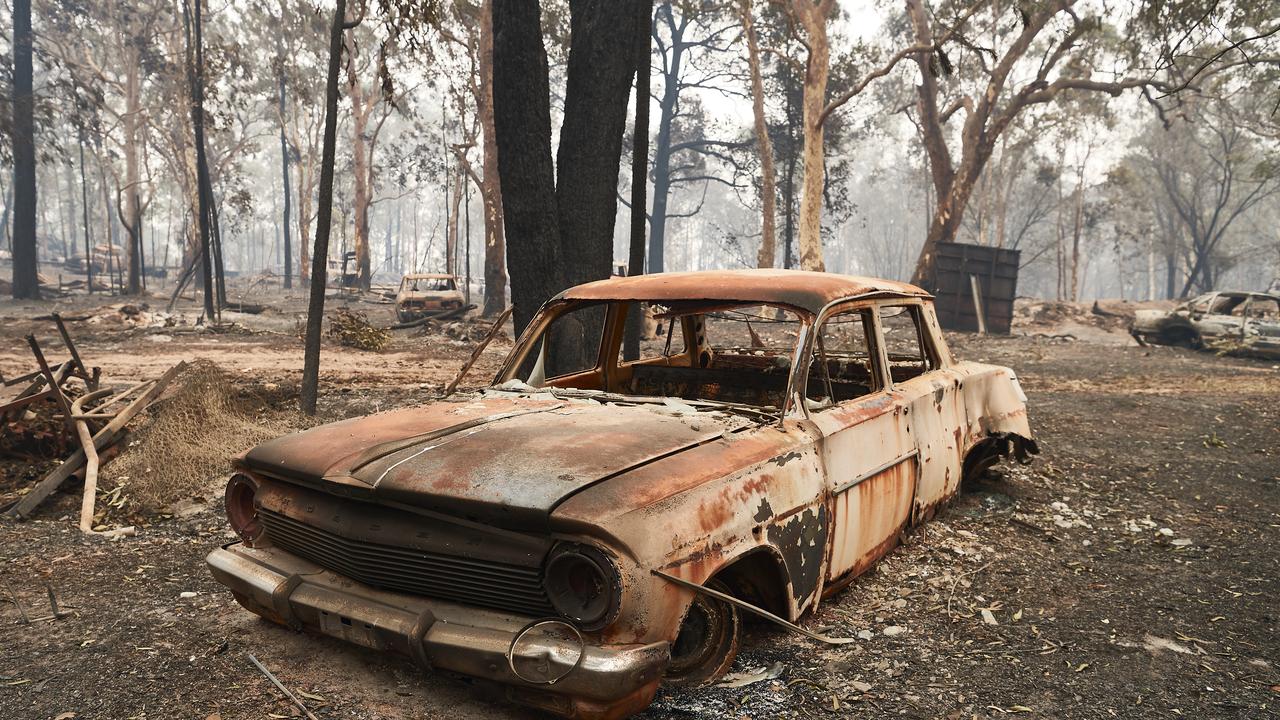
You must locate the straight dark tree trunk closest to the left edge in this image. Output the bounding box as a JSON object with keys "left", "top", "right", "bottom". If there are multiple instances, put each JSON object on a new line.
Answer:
{"left": 13, "top": 0, "right": 40, "bottom": 299}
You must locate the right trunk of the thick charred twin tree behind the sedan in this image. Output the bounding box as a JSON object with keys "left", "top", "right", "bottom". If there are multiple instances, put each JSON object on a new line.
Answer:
{"left": 558, "top": 0, "right": 648, "bottom": 287}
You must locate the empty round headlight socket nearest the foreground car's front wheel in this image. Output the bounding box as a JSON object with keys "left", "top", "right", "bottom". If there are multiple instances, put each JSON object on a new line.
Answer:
{"left": 544, "top": 544, "right": 622, "bottom": 630}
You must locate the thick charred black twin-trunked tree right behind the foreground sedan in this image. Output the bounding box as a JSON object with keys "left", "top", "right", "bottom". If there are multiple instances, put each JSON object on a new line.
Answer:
{"left": 493, "top": 0, "right": 640, "bottom": 332}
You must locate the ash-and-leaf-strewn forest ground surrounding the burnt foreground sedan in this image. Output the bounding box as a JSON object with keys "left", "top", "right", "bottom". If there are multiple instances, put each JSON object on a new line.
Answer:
{"left": 0, "top": 280, "right": 1280, "bottom": 720}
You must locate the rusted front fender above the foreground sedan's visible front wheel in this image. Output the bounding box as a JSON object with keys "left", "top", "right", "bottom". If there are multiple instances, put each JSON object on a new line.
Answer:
{"left": 552, "top": 420, "right": 829, "bottom": 642}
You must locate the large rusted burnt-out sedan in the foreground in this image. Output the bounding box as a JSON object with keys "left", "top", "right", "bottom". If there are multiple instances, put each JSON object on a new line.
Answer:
{"left": 207, "top": 270, "right": 1037, "bottom": 717}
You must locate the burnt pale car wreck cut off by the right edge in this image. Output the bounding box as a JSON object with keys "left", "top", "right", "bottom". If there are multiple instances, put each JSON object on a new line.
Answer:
{"left": 1129, "top": 292, "right": 1280, "bottom": 359}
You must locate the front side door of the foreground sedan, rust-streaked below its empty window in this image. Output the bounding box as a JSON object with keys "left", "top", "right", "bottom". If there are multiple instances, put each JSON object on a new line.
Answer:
{"left": 804, "top": 299, "right": 916, "bottom": 593}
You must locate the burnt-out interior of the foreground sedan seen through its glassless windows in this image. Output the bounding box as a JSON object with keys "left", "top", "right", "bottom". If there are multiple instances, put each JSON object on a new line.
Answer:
{"left": 506, "top": 301, "right": 934, "bottom": 409}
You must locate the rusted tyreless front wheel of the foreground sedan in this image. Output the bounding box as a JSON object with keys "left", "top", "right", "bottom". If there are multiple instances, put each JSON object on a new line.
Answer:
{"left": 666, "top": 580, "right": 742, "bottom": 687}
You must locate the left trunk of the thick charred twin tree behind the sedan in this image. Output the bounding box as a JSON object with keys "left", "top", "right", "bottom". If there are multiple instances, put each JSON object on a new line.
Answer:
{"left": 493, "top": 1, "right": 563, "bottom": 333}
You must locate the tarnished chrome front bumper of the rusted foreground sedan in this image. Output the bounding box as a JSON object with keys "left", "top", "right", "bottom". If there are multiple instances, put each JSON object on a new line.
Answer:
{"left": 206, "top": 543, "right": 669, "bottom": 717}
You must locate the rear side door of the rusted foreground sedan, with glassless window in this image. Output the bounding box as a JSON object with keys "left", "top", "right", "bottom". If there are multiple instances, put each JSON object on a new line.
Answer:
{"left": 878, "top": 301, "right": 966, "bottom": 523}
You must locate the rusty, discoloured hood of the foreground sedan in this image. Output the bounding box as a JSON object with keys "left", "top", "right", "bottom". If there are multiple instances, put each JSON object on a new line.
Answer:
{"left": 241, "top": 392, "right": 751, "bottom": 529}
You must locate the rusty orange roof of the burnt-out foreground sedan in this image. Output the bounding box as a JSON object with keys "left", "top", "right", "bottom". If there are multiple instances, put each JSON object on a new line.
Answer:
{"left": 558, "top": 269, "right": 931, "bottom": 314}
